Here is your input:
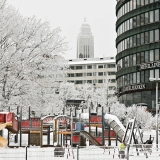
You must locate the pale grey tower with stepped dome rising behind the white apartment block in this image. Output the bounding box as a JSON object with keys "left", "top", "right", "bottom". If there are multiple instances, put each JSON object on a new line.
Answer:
{"left": 77, "top": 19, "right": 94, "bottom": 58}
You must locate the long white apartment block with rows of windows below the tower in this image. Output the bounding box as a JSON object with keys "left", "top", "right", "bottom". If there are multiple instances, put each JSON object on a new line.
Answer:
{"left": 65, "top": 57, "right": 116, "bottom": 87}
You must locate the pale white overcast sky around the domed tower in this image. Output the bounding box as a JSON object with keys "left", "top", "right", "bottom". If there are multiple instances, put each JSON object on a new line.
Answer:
{"left": 7, "top": 0, "right": 116, "bottom": 59}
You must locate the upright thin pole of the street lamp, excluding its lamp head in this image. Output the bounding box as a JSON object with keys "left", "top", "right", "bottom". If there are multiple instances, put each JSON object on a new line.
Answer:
{"left": 156, "top": 81, "right": 158, "bottom": 148}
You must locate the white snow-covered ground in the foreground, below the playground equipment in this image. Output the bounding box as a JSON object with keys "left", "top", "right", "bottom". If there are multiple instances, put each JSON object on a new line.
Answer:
{"left": 0, "top": 146, "right": 160, "bottom": 160}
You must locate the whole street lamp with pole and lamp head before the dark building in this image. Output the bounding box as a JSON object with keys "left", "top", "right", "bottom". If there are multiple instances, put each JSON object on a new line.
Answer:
{"left": 149, "top": 78, "right": 160, "bottom": 147}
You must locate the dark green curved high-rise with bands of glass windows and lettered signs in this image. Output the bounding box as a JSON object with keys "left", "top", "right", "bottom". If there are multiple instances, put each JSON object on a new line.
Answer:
{"left": 116, "top": 0, "right": 160, "bottom": 112}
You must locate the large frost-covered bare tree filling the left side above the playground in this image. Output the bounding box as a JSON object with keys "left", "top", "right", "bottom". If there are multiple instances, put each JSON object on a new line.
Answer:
{"left": 0, "top": 0, "right": 67, "bottom": 115}
